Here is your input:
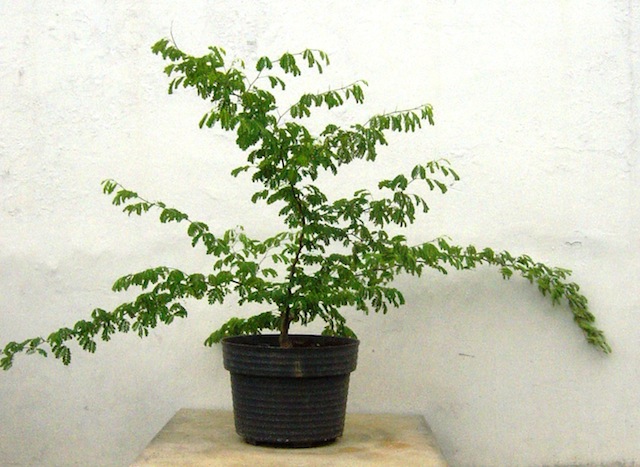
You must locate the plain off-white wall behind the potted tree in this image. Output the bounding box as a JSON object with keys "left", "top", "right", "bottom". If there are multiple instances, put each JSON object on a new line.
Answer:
{"left": 0, "top": 0, "right": 640, "bottom": 465}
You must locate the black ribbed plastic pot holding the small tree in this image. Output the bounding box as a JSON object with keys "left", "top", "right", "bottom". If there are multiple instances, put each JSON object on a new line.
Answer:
{"left": 222, "top": 335, "right": 359, "bottom": 447}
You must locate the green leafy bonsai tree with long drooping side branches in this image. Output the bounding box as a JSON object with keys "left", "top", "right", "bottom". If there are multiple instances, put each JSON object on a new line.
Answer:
{"left": 0, "top": 39, "right": 611, "bottom": 370}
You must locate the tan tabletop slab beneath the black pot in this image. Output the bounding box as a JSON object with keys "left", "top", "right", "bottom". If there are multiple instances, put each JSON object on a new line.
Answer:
{"left": 132, "top": 409, "right": 447, "bottom": 467}
